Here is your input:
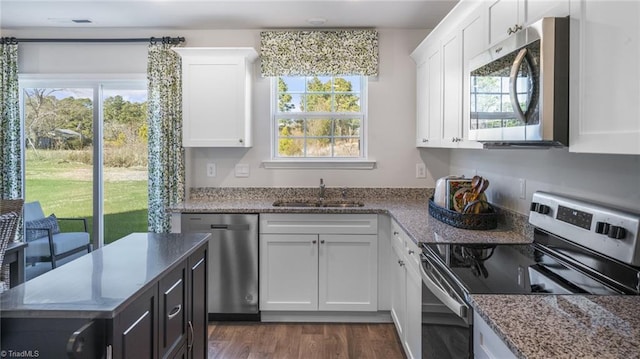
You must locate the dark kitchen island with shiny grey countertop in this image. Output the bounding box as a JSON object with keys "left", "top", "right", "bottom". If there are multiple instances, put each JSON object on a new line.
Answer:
{"left": 0, "top": 233, "right": 210, "bottom": 358}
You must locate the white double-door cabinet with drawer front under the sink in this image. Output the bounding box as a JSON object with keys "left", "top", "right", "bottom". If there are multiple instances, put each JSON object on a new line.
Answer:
{"left": 260, "top": 214, "right": 378, "bottom": 311}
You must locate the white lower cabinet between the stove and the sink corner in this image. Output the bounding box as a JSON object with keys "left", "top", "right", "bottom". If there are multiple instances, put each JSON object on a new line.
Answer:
{"left": 391, "top": 222, "right": 422, "bottom": 359}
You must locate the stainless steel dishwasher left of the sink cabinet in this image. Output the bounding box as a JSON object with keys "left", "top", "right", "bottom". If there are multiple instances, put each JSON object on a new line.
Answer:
{"left": 181, "top": 213, "right": 260, "bottom": 320}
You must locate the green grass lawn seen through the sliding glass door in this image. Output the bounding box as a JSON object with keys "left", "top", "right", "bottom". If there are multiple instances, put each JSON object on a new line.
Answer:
{"left": 25, "top": 150, "right": 147, "bottom": 244}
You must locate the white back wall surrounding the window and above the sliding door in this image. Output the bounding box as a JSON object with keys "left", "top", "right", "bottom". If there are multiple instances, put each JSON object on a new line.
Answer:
{"left": 3, "top": 29, "right": 449, "bottom": 187}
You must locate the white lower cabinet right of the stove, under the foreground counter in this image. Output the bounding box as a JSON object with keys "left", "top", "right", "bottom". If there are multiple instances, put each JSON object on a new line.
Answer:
{"left": 473, "top": 313, "right": 516, "bottom": 359}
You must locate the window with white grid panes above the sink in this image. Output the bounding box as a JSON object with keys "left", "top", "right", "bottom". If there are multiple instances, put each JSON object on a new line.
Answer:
{"left": 272, "top": 76, "right": 366, "bottom": 160}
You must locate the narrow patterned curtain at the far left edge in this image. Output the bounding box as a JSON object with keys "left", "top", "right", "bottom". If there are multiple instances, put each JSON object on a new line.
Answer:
{"left": 0, "top": 38, "right": 22, "bottom": 199}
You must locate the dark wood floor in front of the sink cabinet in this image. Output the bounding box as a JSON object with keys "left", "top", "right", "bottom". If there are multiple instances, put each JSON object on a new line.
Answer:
{"left": 209, "top": 322, "right": 405, "bottom": 359}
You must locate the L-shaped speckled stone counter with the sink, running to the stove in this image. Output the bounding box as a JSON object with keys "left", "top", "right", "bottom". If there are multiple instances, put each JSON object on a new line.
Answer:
{"left": 171, "top": 188, "right": 533, "bottom": 243}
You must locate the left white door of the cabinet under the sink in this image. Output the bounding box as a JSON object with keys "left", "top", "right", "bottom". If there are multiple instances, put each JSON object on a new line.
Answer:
{"left": 260, "top": 234, "right": 318, "bottom": 310}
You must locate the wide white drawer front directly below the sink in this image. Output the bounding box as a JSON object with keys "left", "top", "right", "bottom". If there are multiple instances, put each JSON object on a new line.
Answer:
{"left": 260, "top": 214, "right": 378, "bottom": 234}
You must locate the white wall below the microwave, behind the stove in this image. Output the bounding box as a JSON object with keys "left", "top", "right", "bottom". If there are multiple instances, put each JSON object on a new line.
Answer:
{"left": 444, "top": 149, "right": 640, "bottom": 214}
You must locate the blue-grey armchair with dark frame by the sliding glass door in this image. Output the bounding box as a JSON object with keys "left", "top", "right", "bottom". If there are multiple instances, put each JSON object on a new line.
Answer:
{"left": 24, "top": 201, "right": 91, "bottom": 268}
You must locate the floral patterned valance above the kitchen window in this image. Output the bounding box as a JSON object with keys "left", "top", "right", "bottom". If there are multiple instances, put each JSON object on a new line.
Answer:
{"left": 260, "top": 30, "right": 378, "bottom": 77}
